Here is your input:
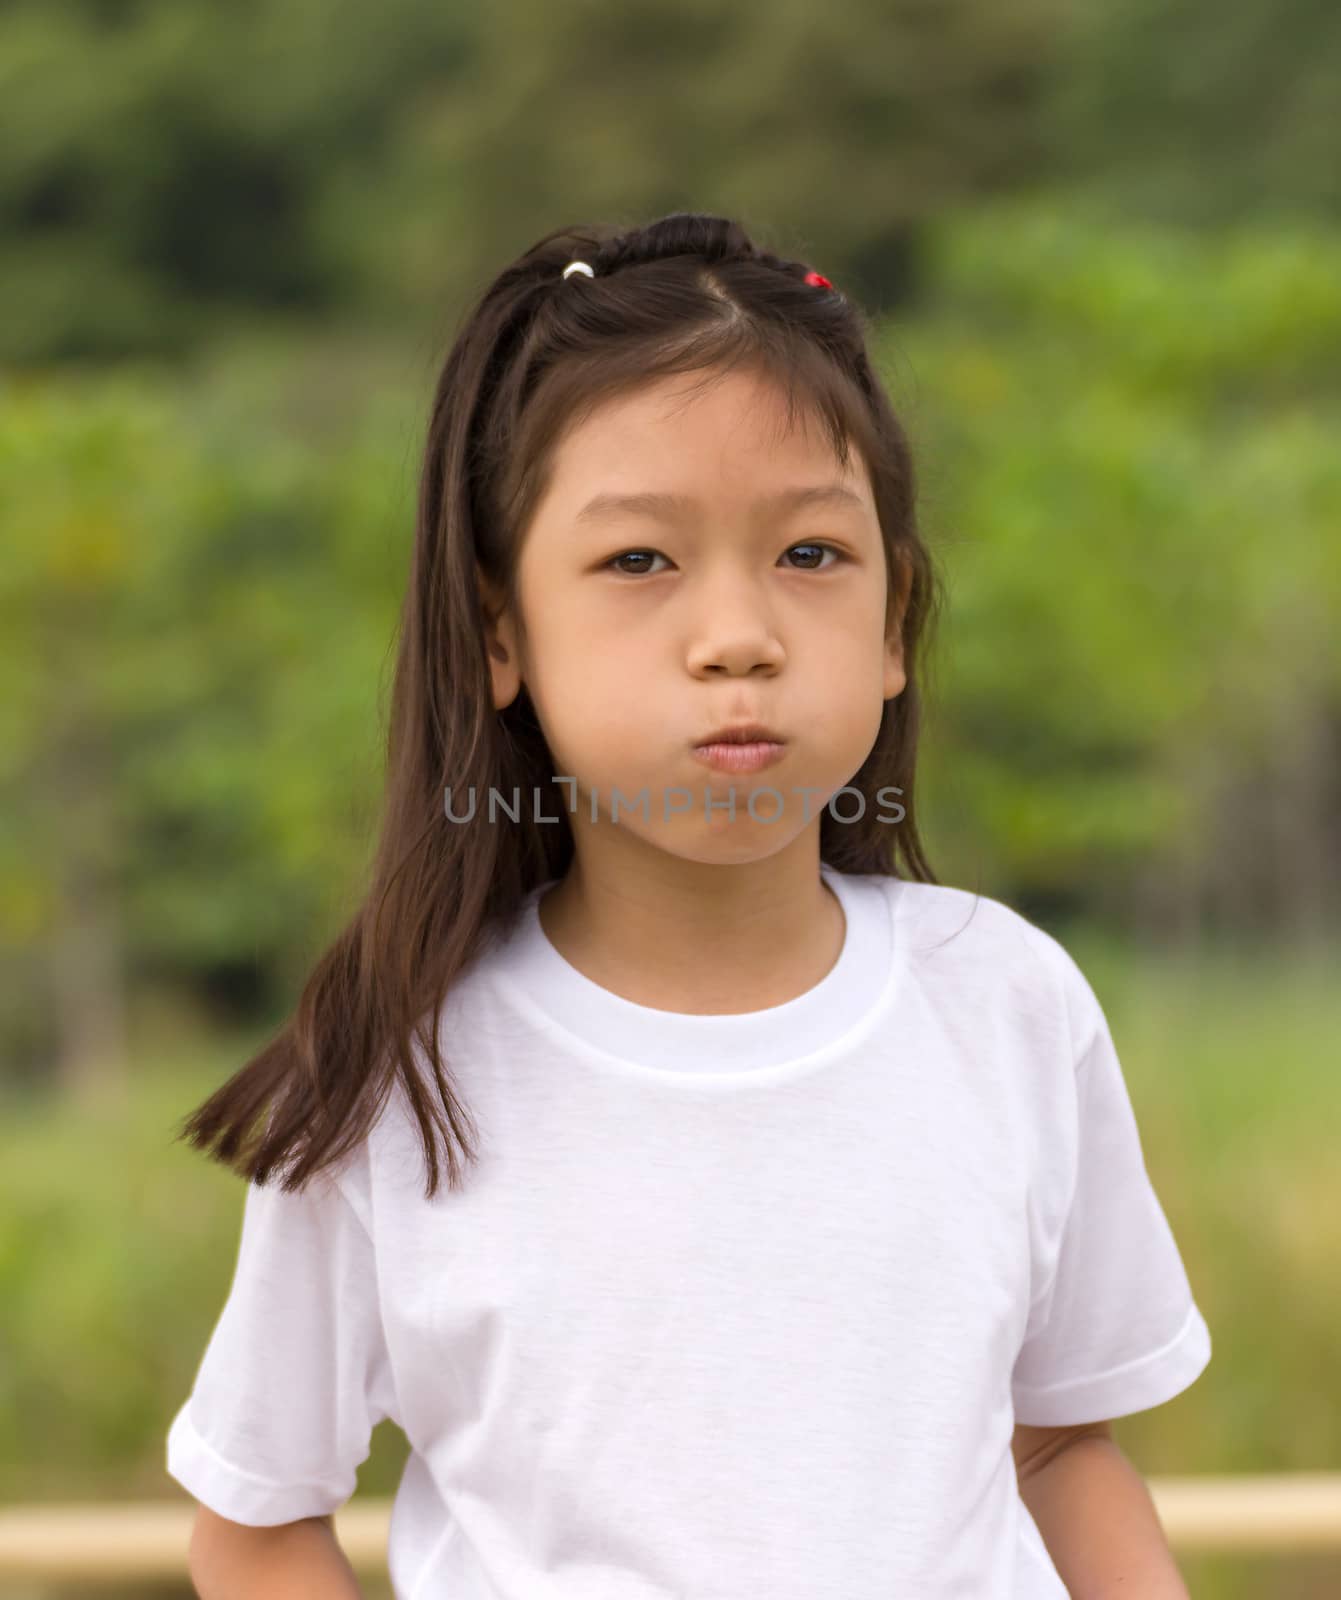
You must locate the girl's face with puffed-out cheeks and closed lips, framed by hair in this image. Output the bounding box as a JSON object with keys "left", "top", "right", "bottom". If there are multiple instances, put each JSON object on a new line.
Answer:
{"left": 491, "top": 371, "right": 906, "bottom": 862}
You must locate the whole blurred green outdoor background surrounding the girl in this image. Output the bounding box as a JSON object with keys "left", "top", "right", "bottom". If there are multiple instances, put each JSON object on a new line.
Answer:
{"left": 0, "top": 0, "right": 1341, "bottom": 1600}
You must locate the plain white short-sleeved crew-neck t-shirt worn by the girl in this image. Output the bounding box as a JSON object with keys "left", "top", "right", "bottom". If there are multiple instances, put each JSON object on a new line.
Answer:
{"left": 166, "top": 866, "right": 1211, "bottom": 1600}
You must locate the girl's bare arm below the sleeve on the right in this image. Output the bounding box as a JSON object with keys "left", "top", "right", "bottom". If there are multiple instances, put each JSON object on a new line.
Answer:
{"left": 1016, "top": 1422, "right": 1189, "bottom": 1600}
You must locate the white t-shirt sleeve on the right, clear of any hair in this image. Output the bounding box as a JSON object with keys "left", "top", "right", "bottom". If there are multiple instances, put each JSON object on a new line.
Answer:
{"left": 1011, "top": 957, "right": 1211, "bottom": 1427}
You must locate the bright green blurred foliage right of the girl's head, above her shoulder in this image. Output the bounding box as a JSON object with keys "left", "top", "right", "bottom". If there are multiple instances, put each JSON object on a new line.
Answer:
{"left": 902, "top": 200, "right": 1341, "bottom": 938}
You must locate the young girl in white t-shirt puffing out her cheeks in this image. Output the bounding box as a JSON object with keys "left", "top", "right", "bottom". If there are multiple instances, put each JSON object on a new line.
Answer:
{"left": 166, "top": 214, "right": 1210, "bottom": 1600}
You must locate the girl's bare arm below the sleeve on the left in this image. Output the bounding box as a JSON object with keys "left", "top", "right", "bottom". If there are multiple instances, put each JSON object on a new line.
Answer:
{"left": 189, "top": 1506, "right": 363, "bottom": 1600}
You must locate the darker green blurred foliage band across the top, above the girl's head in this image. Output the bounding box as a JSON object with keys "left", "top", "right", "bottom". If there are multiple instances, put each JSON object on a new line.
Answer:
{"left": 0, "top": 0, "right": 1341, "bottom": 362}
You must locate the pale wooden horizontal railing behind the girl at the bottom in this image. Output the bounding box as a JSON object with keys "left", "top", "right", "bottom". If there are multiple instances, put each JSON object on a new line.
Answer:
{"left": 0, "top": 1472, "right": 1341, "bottom": 1586}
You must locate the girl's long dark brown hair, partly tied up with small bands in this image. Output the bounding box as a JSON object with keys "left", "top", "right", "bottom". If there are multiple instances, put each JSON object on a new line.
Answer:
{"left": 178, "top": 213, "right": 943, "bottom": 1198}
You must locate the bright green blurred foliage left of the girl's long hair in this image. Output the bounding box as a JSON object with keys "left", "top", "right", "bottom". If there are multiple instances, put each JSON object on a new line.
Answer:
{"left": 0, "top": 374, "right": 408, "bottom": 1099}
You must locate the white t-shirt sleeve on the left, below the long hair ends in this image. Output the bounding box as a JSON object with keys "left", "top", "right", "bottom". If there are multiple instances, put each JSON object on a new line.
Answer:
{"left": 166, "top": 1168, "right": 395, "bottom": 1528}
